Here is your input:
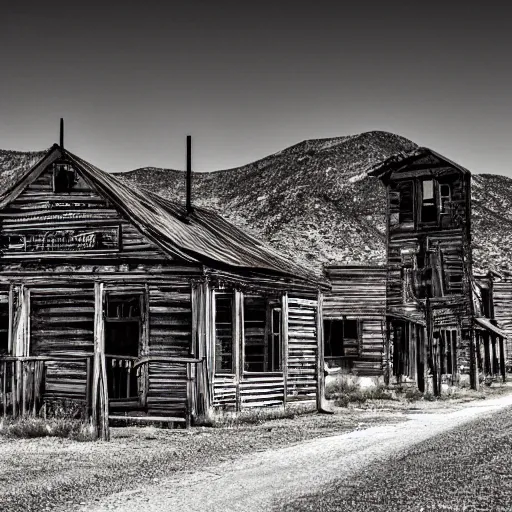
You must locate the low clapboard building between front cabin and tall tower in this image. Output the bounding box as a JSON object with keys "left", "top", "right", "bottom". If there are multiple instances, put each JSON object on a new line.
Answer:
{"left": 323, "top": 265, "right": 387, "bottom": 377}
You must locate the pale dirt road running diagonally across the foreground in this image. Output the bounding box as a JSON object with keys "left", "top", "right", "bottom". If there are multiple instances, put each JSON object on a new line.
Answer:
{"left": 78, "top": 395, "right": 512, "bottom": 512}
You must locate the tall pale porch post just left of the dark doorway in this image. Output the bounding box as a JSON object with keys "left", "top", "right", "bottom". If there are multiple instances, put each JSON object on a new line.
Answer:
{"left": 91, "top": 283, "right": 110, "bottom": 441}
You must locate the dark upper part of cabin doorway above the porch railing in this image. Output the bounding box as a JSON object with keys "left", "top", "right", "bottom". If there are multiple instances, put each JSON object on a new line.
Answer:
{"left": 105, "top": 294, "right": 142, "bottom": 357}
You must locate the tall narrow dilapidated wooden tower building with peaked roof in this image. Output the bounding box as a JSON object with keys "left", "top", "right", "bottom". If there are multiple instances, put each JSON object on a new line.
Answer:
{"left": 370, "top": 148, "right": 504, "bottom": 392}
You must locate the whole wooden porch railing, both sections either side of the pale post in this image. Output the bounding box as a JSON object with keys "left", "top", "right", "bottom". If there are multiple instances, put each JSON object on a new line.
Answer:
{"left": 0, "top": 354, "right": 205, "bottom": 421}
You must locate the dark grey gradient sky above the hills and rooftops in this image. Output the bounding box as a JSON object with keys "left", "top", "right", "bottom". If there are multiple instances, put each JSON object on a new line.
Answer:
{"left": 0, "top": 0, "right": 512, "bottom": 176}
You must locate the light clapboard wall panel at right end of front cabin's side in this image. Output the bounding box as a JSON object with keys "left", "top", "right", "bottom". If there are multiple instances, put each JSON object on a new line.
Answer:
{"left": 286, "top": 297, "right": 318, "bottom": 401}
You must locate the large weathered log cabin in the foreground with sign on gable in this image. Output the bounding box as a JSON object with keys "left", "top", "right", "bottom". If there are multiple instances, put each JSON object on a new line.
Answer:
{"left": 0, "top": 140, "right": 325, "bottom": 435}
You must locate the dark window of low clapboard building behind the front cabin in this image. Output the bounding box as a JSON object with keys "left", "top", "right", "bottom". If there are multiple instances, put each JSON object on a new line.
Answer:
{"left": 324, "top": 320, "right": 360, "bottom": 359}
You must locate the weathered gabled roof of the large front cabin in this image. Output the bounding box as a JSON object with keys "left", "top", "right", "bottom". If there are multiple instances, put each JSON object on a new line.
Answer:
{"left": 0, "top": 145, "right": 325, "bottom": 285}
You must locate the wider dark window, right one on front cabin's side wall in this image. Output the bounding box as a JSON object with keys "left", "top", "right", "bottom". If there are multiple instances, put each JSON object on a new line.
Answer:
{"left": 244, "top": 296, "right": 282, "bottom": 372}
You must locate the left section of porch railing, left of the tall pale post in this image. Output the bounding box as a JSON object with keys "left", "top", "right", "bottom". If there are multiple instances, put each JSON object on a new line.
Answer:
{"left": 0, "top": 355, "right": 92, "bottom": 417}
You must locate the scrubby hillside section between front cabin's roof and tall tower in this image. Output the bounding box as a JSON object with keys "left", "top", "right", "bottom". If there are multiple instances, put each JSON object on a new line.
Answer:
{"left": 118, "top": 132, "right": 416, "bottom": 268}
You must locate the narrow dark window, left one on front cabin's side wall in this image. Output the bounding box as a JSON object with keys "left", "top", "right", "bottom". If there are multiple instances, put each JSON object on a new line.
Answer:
{"left": 215, "top": 293, "right": 234, "bottom": 373}
